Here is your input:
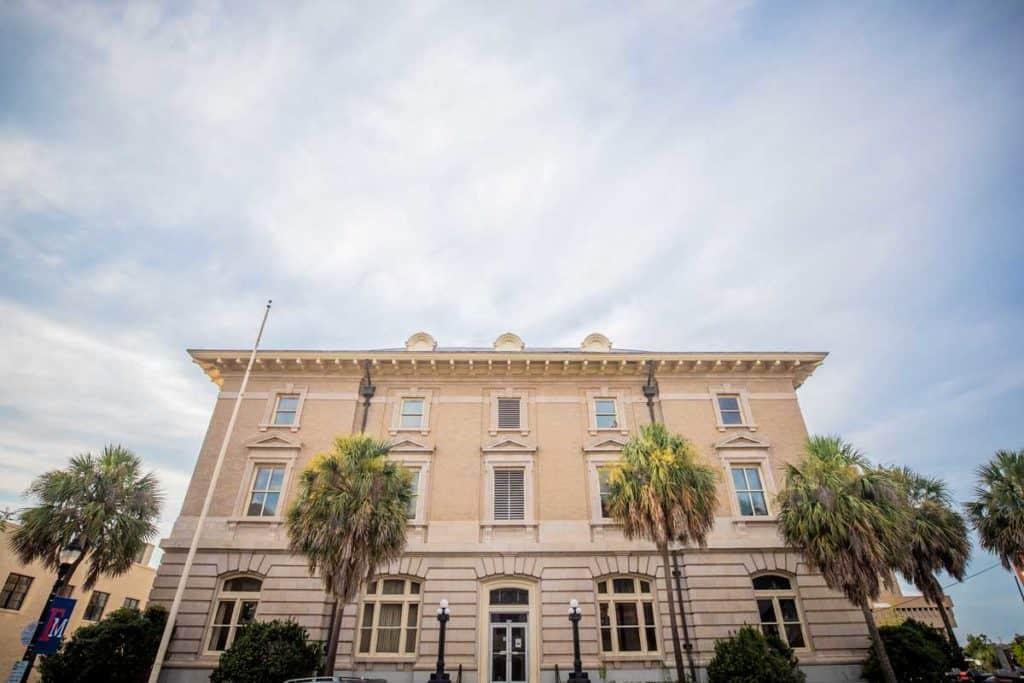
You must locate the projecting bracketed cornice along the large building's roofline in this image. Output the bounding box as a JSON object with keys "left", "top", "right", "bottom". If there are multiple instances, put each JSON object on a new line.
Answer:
{"left": 188, "top": 349, "right": 827, "bottom": 388}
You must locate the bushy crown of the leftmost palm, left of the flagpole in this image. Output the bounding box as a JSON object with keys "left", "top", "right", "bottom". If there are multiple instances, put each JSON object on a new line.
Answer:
{"left": 10, "top": 445, "right": 164, "bottom": 590}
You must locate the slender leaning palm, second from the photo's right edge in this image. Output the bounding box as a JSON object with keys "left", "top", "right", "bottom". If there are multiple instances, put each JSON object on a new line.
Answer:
{"left": 889, "top": 467, "right": 971, "bottom": 664}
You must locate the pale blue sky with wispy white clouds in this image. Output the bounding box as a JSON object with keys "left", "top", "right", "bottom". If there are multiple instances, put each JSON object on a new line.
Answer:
{"left": 0, "top": 0, "right": 1024, "bottom": 638}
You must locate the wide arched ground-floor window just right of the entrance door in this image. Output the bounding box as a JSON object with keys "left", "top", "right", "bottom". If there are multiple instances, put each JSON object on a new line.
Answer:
{"left": 597, "top": 577, "right": 657, "bottom": 652}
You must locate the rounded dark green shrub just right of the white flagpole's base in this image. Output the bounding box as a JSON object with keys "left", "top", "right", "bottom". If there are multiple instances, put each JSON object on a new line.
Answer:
{"left": 210, "top": 620, "right": 323, "bottom": 683}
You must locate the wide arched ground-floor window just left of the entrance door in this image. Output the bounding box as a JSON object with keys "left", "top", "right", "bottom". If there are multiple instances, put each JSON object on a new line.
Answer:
{"left": 359, "top": 579, "right": 420, "bottom": 655}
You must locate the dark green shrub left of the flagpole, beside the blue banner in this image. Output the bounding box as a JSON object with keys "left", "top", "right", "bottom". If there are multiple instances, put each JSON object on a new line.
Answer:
{"left": 39, "top": 605, "right": 167, "bottom": 683}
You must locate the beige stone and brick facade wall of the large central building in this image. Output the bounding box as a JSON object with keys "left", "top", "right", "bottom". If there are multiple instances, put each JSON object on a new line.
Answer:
{"left": 153, "top": 354, "right": 867, "bottom": 681}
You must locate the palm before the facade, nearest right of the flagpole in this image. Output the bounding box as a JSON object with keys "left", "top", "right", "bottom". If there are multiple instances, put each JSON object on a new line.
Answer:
{"left": 288, "top": 434, "right": 413, "bottom": 673}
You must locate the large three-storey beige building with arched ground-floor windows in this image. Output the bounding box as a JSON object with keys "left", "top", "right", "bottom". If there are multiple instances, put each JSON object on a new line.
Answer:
{"left": 152, "top": 333, "right": 868, "bottom": 683}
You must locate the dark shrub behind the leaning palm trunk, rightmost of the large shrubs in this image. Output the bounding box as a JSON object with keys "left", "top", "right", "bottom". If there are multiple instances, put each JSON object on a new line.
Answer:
{"left": 864, "top": 618, "right": 953, "bottom": 683}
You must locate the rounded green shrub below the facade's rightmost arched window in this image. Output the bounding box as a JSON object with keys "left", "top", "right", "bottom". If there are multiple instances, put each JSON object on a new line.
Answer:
{"left": 708, "top": 626, "right": 806, "bottom": 683}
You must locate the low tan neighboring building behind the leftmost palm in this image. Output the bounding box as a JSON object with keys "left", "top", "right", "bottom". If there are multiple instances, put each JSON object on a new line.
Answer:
{"left": 0, "top": 523, "right": 157, "bottom": 676}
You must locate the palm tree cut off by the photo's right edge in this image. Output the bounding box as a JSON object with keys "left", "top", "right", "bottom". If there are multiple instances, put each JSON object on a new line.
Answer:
{"left": 967, "top": 451, "right": 1024, "bottom": 571}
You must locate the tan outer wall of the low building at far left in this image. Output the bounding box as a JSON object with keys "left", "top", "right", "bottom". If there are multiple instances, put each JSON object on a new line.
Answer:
{"left": 0, "top": 524, "right": 157, "bottom": 676}
